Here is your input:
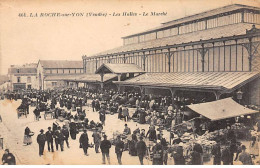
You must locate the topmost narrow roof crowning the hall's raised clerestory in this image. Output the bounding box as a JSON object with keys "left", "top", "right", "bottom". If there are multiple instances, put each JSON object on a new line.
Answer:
{"left": 123, "top": 4, "right": 260, "bottom": 38}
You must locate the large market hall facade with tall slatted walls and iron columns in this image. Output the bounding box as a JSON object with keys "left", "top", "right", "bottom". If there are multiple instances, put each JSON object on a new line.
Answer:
{"left": 82, "top": 4, "right": 260, "bottom": 106}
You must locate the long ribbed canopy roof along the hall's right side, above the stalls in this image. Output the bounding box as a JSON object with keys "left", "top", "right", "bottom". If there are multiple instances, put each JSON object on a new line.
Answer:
{"left": 114, "top": 72, "right": 260, "bottom": 93}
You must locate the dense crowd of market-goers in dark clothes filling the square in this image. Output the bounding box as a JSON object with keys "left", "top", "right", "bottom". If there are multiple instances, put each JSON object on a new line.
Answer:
{"left": 1, "top": 88, "right": 260, "bottom": 165}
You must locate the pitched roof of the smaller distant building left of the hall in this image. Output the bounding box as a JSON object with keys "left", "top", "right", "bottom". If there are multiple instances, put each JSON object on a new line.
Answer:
{"left": 39, "top": 60, "right": 83, "bottom": 69}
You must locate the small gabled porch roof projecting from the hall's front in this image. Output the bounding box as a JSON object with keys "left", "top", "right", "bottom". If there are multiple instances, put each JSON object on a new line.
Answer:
{"left": 95, "top": 64, "right": 145, "bottom": 74}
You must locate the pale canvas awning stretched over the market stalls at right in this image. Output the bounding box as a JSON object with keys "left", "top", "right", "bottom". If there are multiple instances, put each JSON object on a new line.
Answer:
{"left": 188, "top": 98, "right": 259, "bottom": 121}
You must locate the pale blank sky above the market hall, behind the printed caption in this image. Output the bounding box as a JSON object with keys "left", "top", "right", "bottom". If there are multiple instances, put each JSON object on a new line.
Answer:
{"left": 0, "top": 0, "right": 260, "bottom": 74}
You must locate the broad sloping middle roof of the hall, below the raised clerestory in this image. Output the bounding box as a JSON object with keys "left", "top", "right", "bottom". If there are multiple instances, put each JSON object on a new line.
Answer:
{"left": 87, "top": 23, "right": 260, "bottom": 58}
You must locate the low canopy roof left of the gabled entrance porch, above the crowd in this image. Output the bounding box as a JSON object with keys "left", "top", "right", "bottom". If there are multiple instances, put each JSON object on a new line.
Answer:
{"left": 44, "top": 74, "right": 117, "bottom": 83}
